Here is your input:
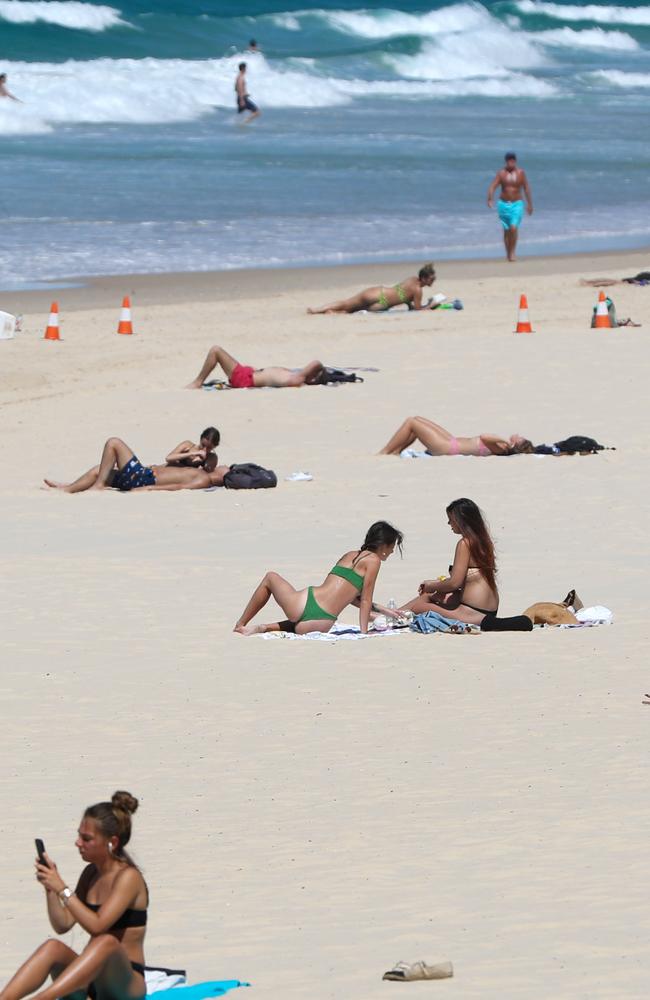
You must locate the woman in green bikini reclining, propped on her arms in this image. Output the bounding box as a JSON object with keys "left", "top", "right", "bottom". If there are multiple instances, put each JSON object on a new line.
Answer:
{"left": 234, "top": 521, "right": 403, "bottom": 635}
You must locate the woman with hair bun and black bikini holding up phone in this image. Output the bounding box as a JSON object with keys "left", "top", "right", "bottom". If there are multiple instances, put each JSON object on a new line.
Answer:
{"left": 0, "top": 792, "right": 149, "bottom": 1000}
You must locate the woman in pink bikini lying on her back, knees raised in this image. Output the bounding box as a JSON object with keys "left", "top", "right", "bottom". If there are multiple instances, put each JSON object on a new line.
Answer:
{"left": 379, "top": 417, "right": 533, "bottom": 456}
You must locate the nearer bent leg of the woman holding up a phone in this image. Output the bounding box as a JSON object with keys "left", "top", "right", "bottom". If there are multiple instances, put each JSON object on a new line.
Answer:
{"left": 33, "top": 934, "right": 145, "bottom": 1000}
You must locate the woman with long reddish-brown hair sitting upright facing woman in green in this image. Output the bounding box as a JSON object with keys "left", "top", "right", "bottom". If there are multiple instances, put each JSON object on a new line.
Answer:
{"left": 400, "top": 497, "right": 499, "bottom": 625}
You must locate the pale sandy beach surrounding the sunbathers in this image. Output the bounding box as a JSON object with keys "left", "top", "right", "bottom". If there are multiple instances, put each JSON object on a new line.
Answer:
{"left": 0, "top": 245, "right": 650, "bottom": 1000}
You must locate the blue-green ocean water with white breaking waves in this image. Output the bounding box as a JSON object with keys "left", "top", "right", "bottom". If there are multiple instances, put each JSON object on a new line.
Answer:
{"left": 0, "top": 0, "right": 650, "bottom": 289}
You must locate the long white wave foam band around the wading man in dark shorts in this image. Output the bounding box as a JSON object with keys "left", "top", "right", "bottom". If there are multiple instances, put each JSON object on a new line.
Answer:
{"left": 0, "top": 54, "right": 555, "bottom": 134}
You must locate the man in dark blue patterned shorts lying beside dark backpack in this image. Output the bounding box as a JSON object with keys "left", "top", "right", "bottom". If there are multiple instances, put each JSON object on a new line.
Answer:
{"left": 43, "top": 438, "right": 230, "bottom": 493}
